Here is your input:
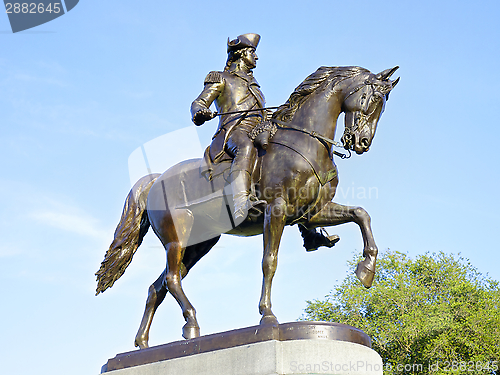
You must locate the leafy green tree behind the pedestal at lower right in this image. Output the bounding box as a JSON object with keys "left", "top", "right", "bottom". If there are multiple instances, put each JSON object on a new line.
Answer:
{"left": 303, "top": 250, "right": 500, "bottom": 375}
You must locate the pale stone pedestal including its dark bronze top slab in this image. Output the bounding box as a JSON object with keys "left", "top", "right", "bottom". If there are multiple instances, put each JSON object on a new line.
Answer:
{"left": 102, "top": 322, "right": 383, "bottom": 375}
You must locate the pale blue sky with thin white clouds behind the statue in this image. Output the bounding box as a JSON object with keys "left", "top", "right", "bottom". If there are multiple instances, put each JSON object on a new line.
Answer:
{"left": 0, "top": 1, "right": 500, "bottom": 375}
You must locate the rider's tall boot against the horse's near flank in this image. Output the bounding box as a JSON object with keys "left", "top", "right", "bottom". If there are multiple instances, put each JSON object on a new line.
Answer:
{"left": 230, "top": 170, "right": 267, "bottom": 222}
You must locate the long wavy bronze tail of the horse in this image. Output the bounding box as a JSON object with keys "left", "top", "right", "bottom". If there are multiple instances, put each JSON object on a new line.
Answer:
{"left": 95, "top": 173, "right": 160, "bottom": 295}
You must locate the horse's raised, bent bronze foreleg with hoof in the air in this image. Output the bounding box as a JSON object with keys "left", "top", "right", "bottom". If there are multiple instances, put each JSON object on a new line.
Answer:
{"left": 305, "top": 202, "right": 378, "bottom": 288}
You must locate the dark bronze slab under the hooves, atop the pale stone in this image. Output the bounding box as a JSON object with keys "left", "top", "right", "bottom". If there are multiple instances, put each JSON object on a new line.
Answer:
{"left": 102, "top": 322, "right": 371, "bottom": 372}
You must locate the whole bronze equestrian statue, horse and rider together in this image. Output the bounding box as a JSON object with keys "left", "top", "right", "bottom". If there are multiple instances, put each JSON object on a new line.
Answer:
{"left": 96, "top": 34, "right": 399, "bottom": 349}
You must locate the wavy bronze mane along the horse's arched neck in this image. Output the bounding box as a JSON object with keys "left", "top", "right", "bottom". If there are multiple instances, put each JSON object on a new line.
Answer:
{"left": 273, "top": 66, "right": 369, "bottom": 121}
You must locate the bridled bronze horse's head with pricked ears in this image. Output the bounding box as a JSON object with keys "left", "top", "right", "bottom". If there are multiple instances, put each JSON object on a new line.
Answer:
{"left": 341, "top": 66, "right": 399, "bottom": 154}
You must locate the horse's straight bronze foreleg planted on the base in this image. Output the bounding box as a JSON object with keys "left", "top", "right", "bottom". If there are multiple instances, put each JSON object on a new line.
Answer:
{"left": 259, "top": 198, "right": 286, "bottom": 325}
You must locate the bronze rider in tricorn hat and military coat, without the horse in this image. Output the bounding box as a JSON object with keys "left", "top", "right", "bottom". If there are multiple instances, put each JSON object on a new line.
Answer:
{"left": 191, "top": 34, "right": 338, "bottom": 251}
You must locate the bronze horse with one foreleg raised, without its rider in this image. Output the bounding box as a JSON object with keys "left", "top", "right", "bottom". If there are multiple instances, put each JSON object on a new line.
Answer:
{"left": 96, "top": 67, "right": 399, "bottom": 349}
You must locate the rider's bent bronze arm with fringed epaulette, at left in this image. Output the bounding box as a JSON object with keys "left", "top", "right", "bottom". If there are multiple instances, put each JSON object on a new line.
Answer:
{"left": 191, "top": 72, "right": 225, "bottom": 125}
